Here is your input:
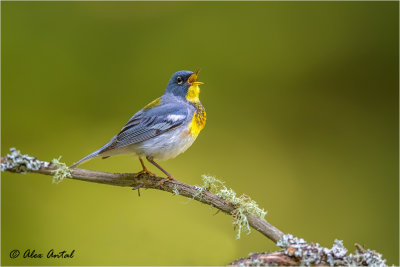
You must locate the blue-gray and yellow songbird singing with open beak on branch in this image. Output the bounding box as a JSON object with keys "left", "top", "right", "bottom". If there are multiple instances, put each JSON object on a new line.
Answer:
{"left": 70, "top": 69, "right": 207, "bottom": 183}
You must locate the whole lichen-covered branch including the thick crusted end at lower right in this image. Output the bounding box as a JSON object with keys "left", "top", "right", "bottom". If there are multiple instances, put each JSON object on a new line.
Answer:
{"left": 0, "top": 148, "right": 386, "bottom": 266}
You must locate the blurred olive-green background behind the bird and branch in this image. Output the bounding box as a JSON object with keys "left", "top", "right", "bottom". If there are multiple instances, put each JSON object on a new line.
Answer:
{"left": 1, "top": 2, "right": 399, "bottom": 265}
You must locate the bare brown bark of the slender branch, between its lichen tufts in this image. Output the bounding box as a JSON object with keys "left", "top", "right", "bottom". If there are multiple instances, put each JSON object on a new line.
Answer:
{"left": 1, "top": 157, "right": 284, "bottom": 243}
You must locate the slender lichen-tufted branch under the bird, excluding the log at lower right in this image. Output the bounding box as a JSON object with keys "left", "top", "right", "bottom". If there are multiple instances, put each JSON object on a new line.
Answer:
{"left": 1, "top": 149, "right": 283, "bottom": 242}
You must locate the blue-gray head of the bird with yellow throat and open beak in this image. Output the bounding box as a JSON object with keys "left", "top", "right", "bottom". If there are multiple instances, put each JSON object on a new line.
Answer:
{"left": 165, "top": 70, "right": 203, "bottom": 102}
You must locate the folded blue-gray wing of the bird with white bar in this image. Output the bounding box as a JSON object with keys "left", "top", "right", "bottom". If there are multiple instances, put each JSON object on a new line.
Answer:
{"left": 99, "top": 103, "right": 189, "bottom": 153}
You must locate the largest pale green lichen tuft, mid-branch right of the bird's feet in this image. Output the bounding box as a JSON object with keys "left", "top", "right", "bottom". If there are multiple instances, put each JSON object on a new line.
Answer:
{"left": 201, "top": 175, "right": 267, "bottom": 239}
